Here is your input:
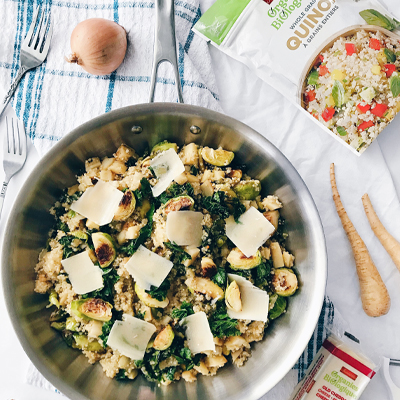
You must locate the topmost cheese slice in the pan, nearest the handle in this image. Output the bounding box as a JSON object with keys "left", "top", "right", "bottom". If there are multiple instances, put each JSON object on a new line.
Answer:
{"left": 150, "top": 149, "right": 185, "bottom": 197}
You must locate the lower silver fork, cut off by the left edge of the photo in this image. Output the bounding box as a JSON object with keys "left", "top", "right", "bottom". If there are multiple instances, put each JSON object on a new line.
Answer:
{"left": 0, "top": 117, "right": 26, "bottom": 216}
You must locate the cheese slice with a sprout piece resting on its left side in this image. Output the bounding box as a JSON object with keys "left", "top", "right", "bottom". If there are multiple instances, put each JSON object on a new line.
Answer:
{"left": 227, "top": 274, "right": 269, "bottom": 322}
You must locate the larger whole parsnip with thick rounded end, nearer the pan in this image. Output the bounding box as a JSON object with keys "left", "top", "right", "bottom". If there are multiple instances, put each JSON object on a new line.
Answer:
{"left": 330, "top": 163, "right": 390, "bottom": 317}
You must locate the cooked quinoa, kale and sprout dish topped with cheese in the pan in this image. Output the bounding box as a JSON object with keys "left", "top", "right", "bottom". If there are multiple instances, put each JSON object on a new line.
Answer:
{"left": 35, "top": 143, "right": 296, "bottom": 384}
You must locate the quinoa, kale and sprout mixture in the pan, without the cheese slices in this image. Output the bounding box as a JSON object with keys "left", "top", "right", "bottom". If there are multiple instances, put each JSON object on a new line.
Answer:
{"left": 35, "top": 142, "right": 297, "bottom": 384}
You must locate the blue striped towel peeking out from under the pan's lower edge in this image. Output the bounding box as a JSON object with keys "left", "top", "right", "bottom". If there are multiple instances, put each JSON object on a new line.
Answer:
{"left": 27, "top": 297, "right": 343, "bottom": 400}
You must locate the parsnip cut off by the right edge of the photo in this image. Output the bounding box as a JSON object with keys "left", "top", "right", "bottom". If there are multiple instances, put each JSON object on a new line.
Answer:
{"left": 362, "top": 193, "right": 400, "bottom": 271}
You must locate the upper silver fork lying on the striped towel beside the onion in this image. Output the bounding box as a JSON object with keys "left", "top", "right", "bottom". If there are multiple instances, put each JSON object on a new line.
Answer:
{"left": 0, "top": 7, "right": 53, "bottom": 117}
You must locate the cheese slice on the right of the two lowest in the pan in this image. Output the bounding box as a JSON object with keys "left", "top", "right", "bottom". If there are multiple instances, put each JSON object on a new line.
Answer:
{"left": 181, "top": 311, "right": 215, "bottom": 354}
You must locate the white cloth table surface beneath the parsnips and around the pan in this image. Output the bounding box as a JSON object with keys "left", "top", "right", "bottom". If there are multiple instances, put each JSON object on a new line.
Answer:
{"left": 0, "top": 0, "right": 400, "bottom": 400}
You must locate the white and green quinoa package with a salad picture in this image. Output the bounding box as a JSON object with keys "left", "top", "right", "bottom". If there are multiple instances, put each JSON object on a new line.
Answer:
{"left": 193, "top": 0, "right": 400, "bottom": 155}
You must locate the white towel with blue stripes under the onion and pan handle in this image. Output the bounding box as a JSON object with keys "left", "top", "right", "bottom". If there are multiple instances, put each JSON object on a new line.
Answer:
{"left": 0, "top": 0, "right": 221, "bottom": 155}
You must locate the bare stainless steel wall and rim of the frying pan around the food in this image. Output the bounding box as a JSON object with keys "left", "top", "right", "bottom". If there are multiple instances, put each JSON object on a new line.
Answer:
{"left": 1, "top": 0, "right": 327, "bottom": 400}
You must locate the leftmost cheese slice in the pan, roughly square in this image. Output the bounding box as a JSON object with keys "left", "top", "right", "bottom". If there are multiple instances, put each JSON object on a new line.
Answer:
{"left": 61, "top": 251, "right": 103, "bottom": 294}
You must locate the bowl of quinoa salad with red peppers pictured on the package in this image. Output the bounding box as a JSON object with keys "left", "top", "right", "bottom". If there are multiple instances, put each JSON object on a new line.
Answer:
{"left": 303, "top": 30, "right": 400, "bottom": 153}
